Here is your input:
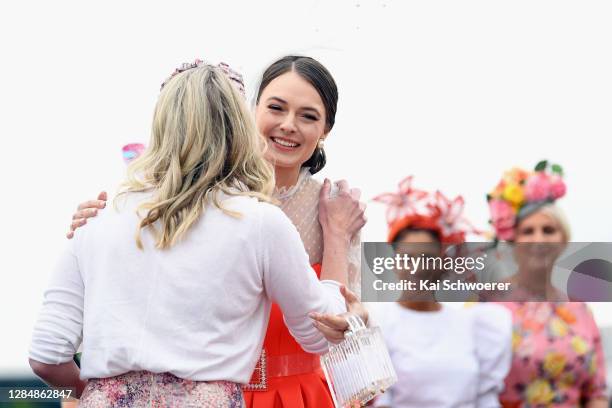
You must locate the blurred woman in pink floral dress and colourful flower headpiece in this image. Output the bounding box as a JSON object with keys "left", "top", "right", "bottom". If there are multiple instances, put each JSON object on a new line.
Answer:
{"left": 488, "top": 162, "right": 608, "bottom": 408}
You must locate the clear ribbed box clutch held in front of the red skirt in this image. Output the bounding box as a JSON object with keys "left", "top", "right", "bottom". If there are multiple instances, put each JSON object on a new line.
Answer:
{"left": 321, "top": 315, "right": 397, "bottom": 408}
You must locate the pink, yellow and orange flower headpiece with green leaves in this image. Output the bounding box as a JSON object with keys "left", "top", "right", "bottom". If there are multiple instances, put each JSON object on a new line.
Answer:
{"left": 487, "top": 160, "right": 567, "bottom": 241}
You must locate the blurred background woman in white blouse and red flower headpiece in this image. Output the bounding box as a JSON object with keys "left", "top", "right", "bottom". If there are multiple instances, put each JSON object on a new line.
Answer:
{"left": 375, "top": 177, "right": 512, "bottom": 408}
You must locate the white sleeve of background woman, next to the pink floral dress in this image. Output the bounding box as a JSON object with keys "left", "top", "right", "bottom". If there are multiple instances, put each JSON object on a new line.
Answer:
{"left": 471, "top": 303, "right": 512, "bottom": 408}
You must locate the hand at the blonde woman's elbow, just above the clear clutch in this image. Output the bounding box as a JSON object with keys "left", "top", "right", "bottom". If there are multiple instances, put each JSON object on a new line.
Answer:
{"left": 310, "top": 285, "right": 369, "bottom": 344}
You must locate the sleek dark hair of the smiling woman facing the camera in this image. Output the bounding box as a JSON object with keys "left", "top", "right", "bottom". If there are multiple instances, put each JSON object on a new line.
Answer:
{"left": 255, "top": 55, "right": 338, "bottom": 174}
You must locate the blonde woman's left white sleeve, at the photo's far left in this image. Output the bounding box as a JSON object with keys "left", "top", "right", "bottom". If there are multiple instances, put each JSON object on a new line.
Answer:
{"left": 29, "top": 241, "right": 85, "bottom": 364}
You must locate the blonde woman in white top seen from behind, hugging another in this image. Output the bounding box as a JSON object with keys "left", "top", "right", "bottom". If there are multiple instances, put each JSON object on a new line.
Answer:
{"left": 30, "top": 62, "right": 363, "bottom": 407}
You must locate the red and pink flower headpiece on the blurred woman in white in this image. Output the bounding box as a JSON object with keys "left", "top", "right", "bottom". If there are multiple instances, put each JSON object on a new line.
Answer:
{"left": 374, "top": 176, "right": 481, "bottom": 244}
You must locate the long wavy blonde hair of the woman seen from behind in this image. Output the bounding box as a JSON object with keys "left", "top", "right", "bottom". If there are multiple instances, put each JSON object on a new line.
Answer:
{"left": 115, "top": 65, "right": 274, "bottom": 249}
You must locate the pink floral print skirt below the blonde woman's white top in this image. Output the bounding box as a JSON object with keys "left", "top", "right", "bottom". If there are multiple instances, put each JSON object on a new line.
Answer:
{"left": 79, "top": 371, "right": 244, "bottom": 408}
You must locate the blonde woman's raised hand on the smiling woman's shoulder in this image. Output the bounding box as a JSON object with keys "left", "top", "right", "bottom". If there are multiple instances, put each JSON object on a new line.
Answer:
{"left": 319, "top": 179, "right": 367, "bottom": 241}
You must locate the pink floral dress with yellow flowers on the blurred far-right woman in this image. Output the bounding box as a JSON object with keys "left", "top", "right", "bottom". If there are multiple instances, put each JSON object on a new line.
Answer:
{"left": 500, "top": 302, "right": 606, "bottom": 408}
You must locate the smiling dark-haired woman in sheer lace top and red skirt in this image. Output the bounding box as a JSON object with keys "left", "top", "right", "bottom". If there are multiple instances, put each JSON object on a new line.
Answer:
{"left": 69, "top": 56, "right": 360, "bottom": 408}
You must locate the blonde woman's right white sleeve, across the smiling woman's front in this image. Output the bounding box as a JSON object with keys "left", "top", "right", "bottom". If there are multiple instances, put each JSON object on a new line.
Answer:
{"left": 260, "top": 205, "right": 346, "bottom": 354}
